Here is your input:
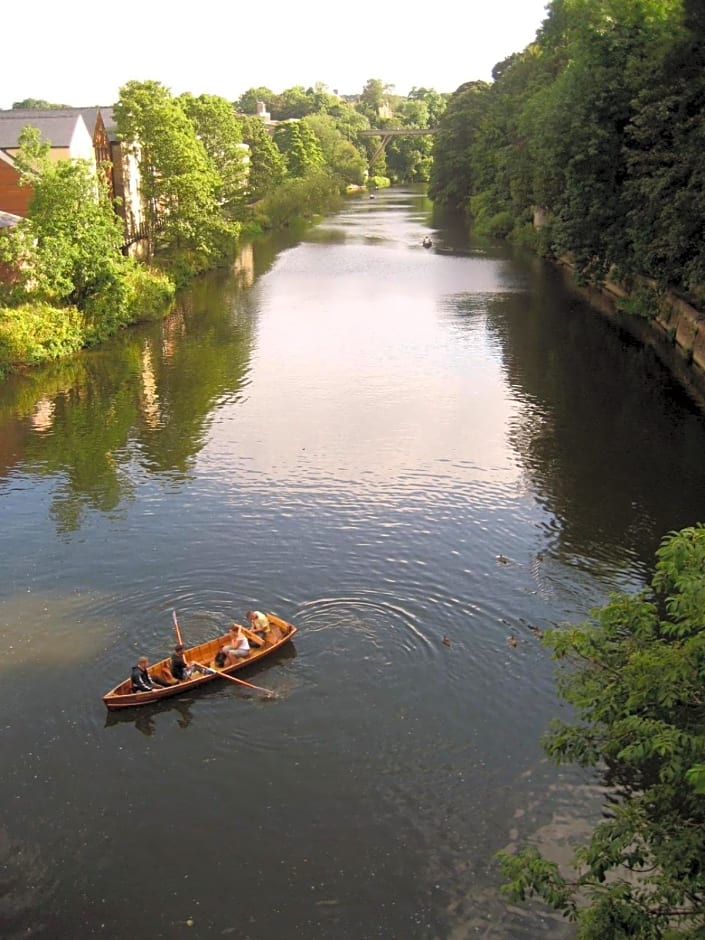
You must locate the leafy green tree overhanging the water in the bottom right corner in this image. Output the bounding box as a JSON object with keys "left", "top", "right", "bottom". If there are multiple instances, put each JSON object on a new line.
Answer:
{"left": 500, "top": 524, "right": 705, "bottom": 940}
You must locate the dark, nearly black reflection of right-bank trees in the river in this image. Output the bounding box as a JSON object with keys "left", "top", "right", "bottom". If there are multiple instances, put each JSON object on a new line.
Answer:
{"left": 478, "top": 268, "right": 705, "bottom": 565}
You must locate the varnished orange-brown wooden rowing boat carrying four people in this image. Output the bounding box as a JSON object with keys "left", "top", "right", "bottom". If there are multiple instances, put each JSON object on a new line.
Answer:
{"left": 103, "top": 613, "right": 296, "bottom": 711}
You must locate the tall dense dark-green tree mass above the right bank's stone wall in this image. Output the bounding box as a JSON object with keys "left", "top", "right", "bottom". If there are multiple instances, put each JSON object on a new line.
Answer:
{"left": 430, "top": 0, "right": 705, "bottom": 299}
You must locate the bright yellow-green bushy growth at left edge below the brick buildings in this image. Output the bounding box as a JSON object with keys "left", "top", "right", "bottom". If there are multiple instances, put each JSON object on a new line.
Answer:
{"left": 0, "top": 123, "right": 174, "bottom": 371}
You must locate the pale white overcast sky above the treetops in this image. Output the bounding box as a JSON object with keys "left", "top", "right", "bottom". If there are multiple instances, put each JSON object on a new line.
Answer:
{"left": 0, "top": 0, "right": 548, "bottom": 108}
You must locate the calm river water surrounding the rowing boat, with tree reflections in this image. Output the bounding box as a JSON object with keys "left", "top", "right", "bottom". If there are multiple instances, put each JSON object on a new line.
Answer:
{"left": 0, "top": 190, "right": 705, "bottom": 940}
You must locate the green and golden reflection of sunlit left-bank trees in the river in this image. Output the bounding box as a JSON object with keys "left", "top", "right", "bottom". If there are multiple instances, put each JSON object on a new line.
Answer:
{"left": 0, "top": 260, "right": 254, "bottom": 532}
